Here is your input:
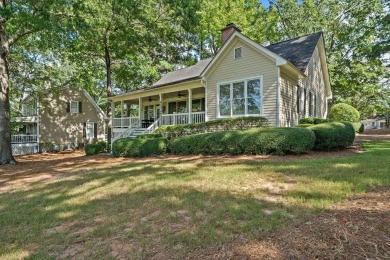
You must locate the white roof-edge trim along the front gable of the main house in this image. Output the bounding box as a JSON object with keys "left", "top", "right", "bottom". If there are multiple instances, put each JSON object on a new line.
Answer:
{"left": 200, "top": 31, "right": 306, "bottom": 77}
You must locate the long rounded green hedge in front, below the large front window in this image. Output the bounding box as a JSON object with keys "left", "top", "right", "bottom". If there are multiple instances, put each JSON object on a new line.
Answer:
{"left": 170, "top": 127, "right": 315, "bottom": 155}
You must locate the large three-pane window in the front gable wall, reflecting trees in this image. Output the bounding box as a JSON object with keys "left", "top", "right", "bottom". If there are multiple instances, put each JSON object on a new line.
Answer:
{"left": 218, "top": 77, "right": 262, "bottom": 117}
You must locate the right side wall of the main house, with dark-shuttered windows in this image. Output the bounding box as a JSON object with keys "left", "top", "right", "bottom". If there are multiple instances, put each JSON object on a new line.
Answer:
{"left": 281, "top": 47, "right": 328, "bottom": 126}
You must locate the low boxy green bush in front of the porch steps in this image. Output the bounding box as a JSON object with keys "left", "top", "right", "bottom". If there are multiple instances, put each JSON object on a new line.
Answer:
{"left": 112, "top": 138, "right": 168, "bottom": 157}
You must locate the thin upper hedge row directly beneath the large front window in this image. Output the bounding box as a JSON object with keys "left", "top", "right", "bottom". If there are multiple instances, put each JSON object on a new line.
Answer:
{"left": 156, "top": 116, "right": 269, "bottom": 139}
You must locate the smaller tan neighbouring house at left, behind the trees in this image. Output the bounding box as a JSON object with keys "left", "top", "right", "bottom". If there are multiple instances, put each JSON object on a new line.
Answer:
{"left": 11, "top": 87, "right": 107, "bottom": 155}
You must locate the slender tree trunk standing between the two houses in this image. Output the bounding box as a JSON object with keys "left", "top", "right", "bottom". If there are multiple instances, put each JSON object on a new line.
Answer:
{"left": 103, "top": 34, "right": 112, "bottom": 144}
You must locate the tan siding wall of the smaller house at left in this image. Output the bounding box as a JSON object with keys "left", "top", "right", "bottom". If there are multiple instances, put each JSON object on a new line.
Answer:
{"left": 39, "top": 88, "right": 104, "bottom": 145}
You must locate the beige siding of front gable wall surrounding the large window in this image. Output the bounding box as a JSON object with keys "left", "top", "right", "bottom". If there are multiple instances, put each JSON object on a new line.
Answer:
{"left": 206, "top": 39, "right": 278, "bottom": 125}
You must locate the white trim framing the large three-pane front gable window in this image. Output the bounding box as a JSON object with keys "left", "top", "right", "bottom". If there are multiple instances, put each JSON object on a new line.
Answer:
{"left": 216, "top": 75, "right": 264, "bottom": 118}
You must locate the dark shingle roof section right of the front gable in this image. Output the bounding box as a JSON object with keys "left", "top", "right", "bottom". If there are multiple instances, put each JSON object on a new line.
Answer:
{"left": 266, "top": 32, "right": 322, "bottom": 72}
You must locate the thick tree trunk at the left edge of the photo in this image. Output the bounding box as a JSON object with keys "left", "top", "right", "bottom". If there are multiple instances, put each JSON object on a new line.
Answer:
{"left": 0, "top": 23, "right": 16, "bottom": 164}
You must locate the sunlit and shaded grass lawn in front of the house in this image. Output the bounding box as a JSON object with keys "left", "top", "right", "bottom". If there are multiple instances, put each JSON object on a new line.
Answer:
{"left": 0, "top": 142, "right": 390, "bottom": 259}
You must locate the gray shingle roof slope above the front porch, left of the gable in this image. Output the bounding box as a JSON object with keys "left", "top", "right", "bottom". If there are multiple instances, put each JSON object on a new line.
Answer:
{"left": 152, "top": 58, "right": 211, "bottom": 88}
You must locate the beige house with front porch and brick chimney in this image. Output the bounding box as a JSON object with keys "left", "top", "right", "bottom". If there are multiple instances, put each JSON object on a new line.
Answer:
{"left": 110, "top": 24, "right": 332, "bottom": 140}
